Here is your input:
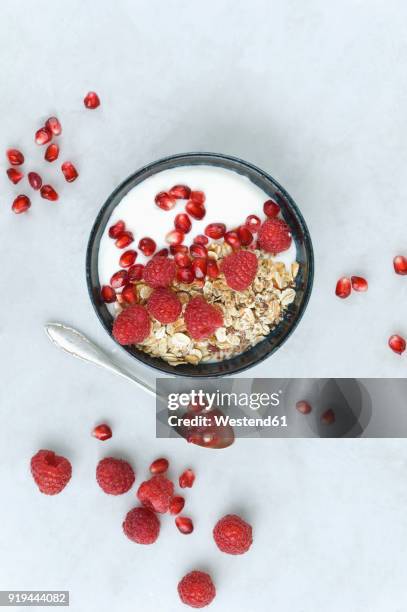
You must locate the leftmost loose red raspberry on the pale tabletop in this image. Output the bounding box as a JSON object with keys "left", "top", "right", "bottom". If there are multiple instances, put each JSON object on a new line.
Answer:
{"left": 31, "top": 450, "right": 72, "bottom": 495}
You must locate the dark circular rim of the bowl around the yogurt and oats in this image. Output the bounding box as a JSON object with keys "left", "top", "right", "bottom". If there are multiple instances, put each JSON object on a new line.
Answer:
{"left": 86, "top": 151, "right": 315, "bottom": 378}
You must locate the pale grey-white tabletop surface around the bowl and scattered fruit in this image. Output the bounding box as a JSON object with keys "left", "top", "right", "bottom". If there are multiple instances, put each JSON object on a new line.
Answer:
{"left": 0, "top": 0, "right": 407, "bottom": 612}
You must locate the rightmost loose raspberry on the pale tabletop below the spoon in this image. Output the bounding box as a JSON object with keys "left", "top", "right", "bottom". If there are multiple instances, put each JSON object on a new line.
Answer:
{"left": 213, "top": 514, "right": 253, "bottom": 555}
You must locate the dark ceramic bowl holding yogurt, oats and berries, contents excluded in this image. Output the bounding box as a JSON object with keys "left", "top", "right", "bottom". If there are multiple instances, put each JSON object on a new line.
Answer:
{"left": 86, "top": 153, "right": 314, "bottom": 377}
